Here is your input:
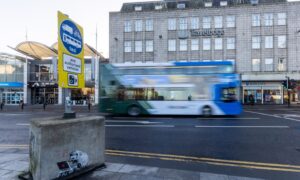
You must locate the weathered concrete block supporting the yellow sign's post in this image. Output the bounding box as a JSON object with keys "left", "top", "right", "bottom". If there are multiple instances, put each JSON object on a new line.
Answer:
{"left": 29, "top": 116, "right": 105, "bottom": 180}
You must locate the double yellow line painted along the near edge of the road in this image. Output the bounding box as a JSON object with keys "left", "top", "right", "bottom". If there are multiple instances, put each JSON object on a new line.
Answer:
{"left": 0, "top": 144, "right": 300, "bottom": 173}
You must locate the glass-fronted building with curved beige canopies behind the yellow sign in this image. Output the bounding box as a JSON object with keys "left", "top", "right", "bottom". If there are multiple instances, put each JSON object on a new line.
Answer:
{"left": 0, "top": 41, "right": 106, "bottom": 105}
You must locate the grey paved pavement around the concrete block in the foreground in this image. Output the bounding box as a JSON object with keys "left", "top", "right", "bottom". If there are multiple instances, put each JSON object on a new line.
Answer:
{"left": 0, "top": 153, "right": 258, "bottom": 180}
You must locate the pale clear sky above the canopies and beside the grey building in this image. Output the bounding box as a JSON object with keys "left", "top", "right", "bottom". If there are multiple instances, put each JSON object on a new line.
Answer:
{"left": 0, "top": 0, "right": 298, "bottom": 58}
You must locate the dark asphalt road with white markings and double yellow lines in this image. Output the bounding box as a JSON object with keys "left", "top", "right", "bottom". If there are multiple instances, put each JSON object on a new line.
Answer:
{"left": 0, "top": 106, "right": 300, "bottom": 179}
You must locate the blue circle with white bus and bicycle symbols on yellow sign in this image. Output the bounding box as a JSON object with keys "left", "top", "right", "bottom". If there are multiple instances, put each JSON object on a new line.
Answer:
{"left": 60, "top": 20, "right": 83, "bottom": 55}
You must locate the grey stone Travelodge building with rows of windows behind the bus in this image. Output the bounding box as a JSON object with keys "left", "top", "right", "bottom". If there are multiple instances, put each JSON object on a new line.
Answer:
{"left": 109, "top": 0, "right": 300, "bottom": 104}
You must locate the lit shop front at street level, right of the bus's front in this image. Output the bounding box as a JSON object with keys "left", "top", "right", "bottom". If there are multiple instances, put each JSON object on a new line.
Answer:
{"left": 242, "top": 82, "right": 284, "bottom": 104}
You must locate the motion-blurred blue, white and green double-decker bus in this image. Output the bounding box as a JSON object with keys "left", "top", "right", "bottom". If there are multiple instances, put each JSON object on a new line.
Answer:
{"left": 99, "top": 61, "right": 242, "bottom": 116}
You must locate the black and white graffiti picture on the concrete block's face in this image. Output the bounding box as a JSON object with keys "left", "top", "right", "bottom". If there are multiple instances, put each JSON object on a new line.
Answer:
{"left": 57, "top": 150, "right": 89, "bottom": 177}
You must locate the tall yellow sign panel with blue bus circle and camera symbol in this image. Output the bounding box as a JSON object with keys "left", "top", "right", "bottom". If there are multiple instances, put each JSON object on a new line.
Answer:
{"left": 58, "top": 11, "right": 85, "bottom": 88}
